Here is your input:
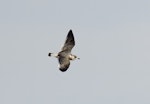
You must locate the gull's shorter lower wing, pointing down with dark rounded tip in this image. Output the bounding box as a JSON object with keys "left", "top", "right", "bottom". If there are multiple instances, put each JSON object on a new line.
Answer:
{"left": 58, "top": 56, "right": 70, "bottom": 72}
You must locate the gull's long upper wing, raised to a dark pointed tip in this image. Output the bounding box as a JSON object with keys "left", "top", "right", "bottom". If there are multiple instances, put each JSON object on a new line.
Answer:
{"left": 61, "top": 30, "right": 75, "bottom": 52}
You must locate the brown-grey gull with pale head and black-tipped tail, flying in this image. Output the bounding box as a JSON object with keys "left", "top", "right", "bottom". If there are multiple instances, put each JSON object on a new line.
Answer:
{"left": 48, "top": 29, "right": 80, "bottom": 72}
